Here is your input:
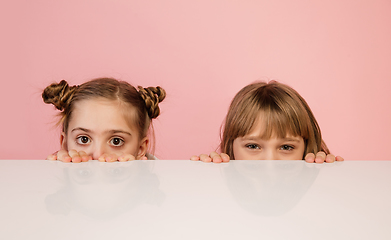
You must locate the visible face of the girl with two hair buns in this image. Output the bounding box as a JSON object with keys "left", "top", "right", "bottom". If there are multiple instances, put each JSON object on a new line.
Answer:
{"left": 61, "top": 98, "right": 148, "bottom": 159}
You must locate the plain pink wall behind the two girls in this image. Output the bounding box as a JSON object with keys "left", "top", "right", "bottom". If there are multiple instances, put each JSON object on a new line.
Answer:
{"left": 0, "top": 0, "right": 391, "bottom": 160}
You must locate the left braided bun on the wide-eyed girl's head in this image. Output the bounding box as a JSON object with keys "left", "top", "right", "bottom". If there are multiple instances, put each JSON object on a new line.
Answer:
{"left": 42, "top": 80, "right": 77, "bottom": 111}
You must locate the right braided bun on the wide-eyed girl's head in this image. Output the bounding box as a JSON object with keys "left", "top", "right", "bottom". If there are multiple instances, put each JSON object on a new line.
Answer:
{"left": 138, "top": 86, "right": 166, "bottom": 119}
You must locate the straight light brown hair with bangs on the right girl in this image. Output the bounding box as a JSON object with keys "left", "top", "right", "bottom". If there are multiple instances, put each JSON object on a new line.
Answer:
{"left": 220, "top": 81, "right": 330, "bottom": 159}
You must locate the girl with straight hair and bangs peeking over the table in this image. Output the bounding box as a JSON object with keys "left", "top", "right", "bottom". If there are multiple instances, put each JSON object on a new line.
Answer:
{"left": 191, "top": 81, "right": 344, "bottom": 163}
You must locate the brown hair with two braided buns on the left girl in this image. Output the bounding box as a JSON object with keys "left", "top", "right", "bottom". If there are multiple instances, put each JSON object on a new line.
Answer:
{"left": 42, "top": 78, "right": 166, "bottom": 152}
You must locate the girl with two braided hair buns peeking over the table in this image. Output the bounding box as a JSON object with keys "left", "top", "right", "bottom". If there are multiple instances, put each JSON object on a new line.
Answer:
{"left": 42, "top": 78, "right": 166, "bottom": 162}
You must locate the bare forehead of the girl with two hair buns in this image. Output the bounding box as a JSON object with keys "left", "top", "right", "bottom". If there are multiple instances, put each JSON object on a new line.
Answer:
{"left": 69, "top": 98, "right": 134, "bottom": 132}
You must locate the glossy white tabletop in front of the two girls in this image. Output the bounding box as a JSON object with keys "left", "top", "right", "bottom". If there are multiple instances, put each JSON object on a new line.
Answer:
{"left": 0, "top": 160, "right": 391, "bottom": 240}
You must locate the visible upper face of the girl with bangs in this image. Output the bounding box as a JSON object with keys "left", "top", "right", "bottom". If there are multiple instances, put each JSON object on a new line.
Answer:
{"left": 233, "top": 118, "right": 305, "bottom": 160}
